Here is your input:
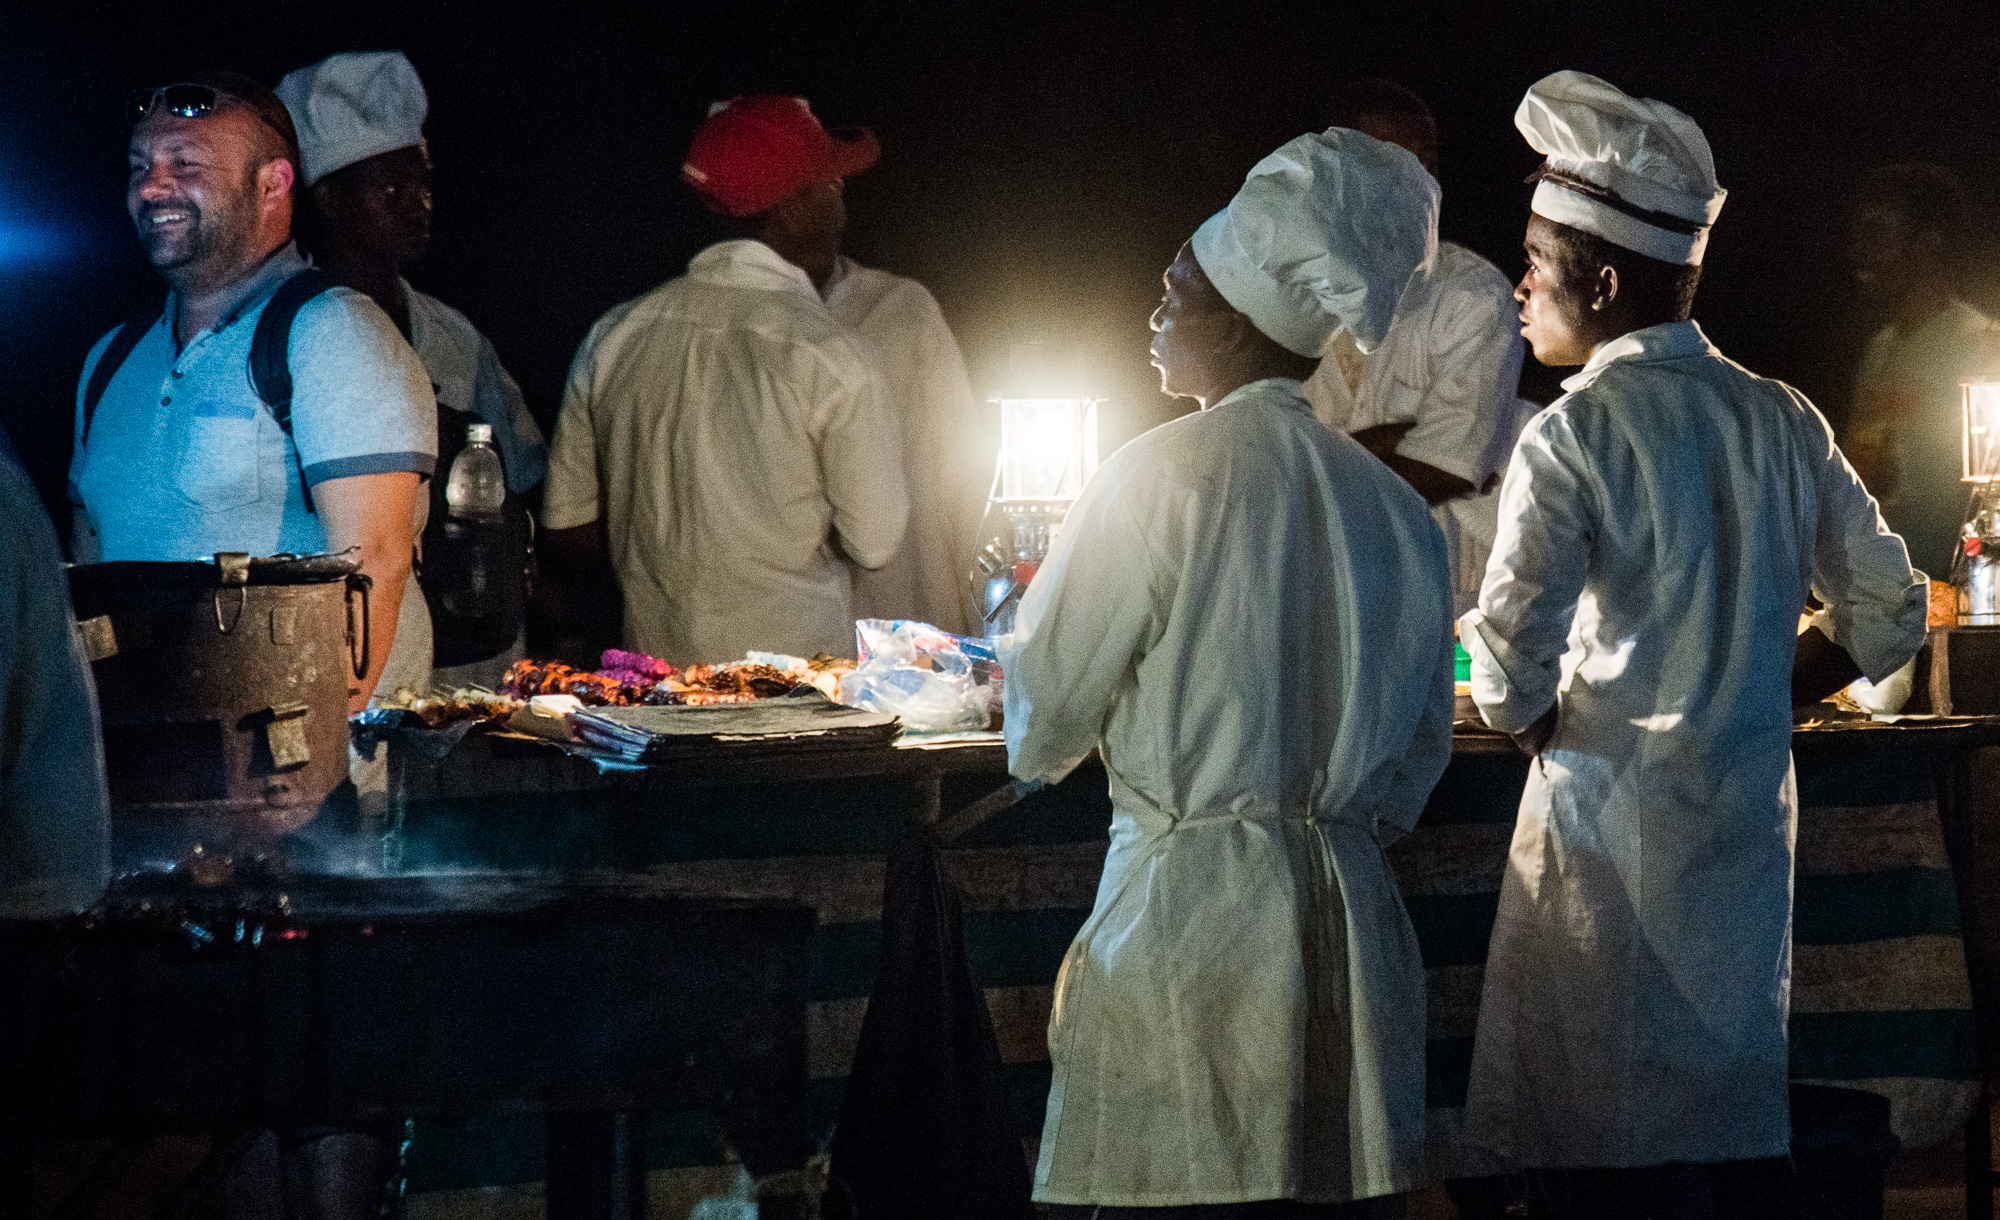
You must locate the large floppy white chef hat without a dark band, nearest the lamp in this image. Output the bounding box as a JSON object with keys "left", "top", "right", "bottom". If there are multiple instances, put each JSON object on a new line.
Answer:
{"left": 1192, "top": 128, "right": 1438, "bottom": 356}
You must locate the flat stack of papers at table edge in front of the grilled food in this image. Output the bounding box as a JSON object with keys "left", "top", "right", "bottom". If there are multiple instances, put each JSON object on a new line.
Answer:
{"left": 568, "top": 690, "right": 902, "bottom": 764}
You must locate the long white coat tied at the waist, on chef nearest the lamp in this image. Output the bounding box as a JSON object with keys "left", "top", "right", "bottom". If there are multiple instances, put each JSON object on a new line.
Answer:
{"left": 1000, "top": 378, "right": 1452, "bottom": 1206}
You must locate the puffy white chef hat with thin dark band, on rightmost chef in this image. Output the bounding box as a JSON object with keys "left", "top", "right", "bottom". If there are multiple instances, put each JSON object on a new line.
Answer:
{"left": 1514, "top": 72, "right": 1728, "bottom": 266}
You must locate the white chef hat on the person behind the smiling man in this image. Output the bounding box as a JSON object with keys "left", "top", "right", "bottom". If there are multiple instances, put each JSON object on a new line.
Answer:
{"left": 278, "top": 50, "right": 430, "bottom": 186}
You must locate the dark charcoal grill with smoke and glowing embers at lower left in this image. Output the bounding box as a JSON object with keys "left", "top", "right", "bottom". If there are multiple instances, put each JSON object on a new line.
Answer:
{"left": 0, "top": 874, "right": 814, "bottom": 1220}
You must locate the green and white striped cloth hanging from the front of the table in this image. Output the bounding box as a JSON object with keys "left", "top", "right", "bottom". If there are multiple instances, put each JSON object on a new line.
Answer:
{"left": 394, "top": 728, "right": 1978, "bottom": 1220}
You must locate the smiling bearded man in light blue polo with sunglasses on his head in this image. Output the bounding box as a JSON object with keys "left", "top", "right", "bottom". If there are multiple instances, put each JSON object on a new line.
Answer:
{"left": 70, "top": 72, "right": 438, "bottom": 710}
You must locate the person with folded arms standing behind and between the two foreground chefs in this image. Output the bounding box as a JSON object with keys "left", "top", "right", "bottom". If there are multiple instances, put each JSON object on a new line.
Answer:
{"left": 1306, "top": 80, "right": 1532, "bottom": 616}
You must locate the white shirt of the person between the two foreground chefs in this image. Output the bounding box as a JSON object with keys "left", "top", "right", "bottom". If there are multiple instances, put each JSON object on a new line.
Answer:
{"left": 1306, "top": 242, "right": 1528, "bottom": 614}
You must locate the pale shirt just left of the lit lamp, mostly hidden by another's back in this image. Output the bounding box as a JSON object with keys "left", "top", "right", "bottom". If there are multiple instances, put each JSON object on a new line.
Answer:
{"left": 826, "top": 254, "right": 992, "bottom": 634}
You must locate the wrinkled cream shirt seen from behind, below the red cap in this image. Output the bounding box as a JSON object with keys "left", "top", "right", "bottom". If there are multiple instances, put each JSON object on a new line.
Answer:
{"left": 542, "top": 240, "right": 908, "bottom": 664}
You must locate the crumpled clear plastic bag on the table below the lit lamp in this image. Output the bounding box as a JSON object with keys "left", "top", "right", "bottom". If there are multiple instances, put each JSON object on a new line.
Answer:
{"left": 840, "top": 618, "right": 1000, "bottom": 732}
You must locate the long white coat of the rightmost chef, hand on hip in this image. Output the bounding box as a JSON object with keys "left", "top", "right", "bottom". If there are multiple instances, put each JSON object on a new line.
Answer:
{"left": 1460, "top": 322, "right": 1926, "bottom": 1168}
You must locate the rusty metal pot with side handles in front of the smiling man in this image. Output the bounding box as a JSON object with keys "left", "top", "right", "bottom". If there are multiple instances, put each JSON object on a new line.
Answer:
{"left": 70, "top": 554, "right": 368, "bottom": 840}
